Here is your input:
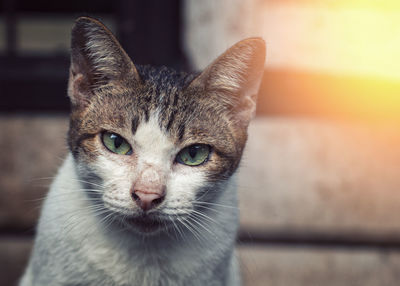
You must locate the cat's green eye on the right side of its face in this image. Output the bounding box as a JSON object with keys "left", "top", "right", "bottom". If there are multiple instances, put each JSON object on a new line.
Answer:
{"left": 176, "top": 144, "right": 210, "bottom": 166}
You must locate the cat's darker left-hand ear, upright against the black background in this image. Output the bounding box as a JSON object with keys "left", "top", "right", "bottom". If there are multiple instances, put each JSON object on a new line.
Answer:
{"left": 68, "top": 17, "right": 140, "bottom": 107}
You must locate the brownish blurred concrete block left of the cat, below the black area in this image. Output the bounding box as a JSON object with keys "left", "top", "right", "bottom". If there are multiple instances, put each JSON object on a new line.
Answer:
{"left": 0, "top": 116, "right": 68, "bottom": 230}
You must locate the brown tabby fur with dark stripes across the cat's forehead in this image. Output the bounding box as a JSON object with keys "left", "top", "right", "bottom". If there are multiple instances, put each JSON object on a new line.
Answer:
{"left": 69, "top": 63, "right": 246, "bottom": 179}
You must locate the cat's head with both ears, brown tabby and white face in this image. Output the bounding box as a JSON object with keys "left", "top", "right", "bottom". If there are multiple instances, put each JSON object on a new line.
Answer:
{"left": 68, "top": 17, "right": 265, "bottom": 236}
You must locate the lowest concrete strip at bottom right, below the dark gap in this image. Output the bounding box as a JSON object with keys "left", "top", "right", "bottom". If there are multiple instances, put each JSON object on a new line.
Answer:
{"left": 239, "top": 246, "right": 400, "bottom": 286}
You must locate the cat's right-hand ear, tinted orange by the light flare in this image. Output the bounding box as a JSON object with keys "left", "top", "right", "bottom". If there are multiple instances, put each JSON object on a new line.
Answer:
{"left": 190, "top": 38, "right": 265, "bottom": 124}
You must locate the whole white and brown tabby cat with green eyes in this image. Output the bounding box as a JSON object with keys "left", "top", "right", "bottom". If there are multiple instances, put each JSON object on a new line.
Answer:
{"left": 20, "top": 17, "right": 265, "bottom": 286}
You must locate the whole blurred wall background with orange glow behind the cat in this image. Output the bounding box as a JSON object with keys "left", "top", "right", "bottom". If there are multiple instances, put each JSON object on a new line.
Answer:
{"left": 0, "top": 0, "right": 400, "bottom": 286}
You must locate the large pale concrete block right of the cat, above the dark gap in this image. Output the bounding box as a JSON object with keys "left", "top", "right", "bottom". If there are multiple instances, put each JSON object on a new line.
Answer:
{"left": 239, "top": 118, "right": 400, "bottom": 238}
